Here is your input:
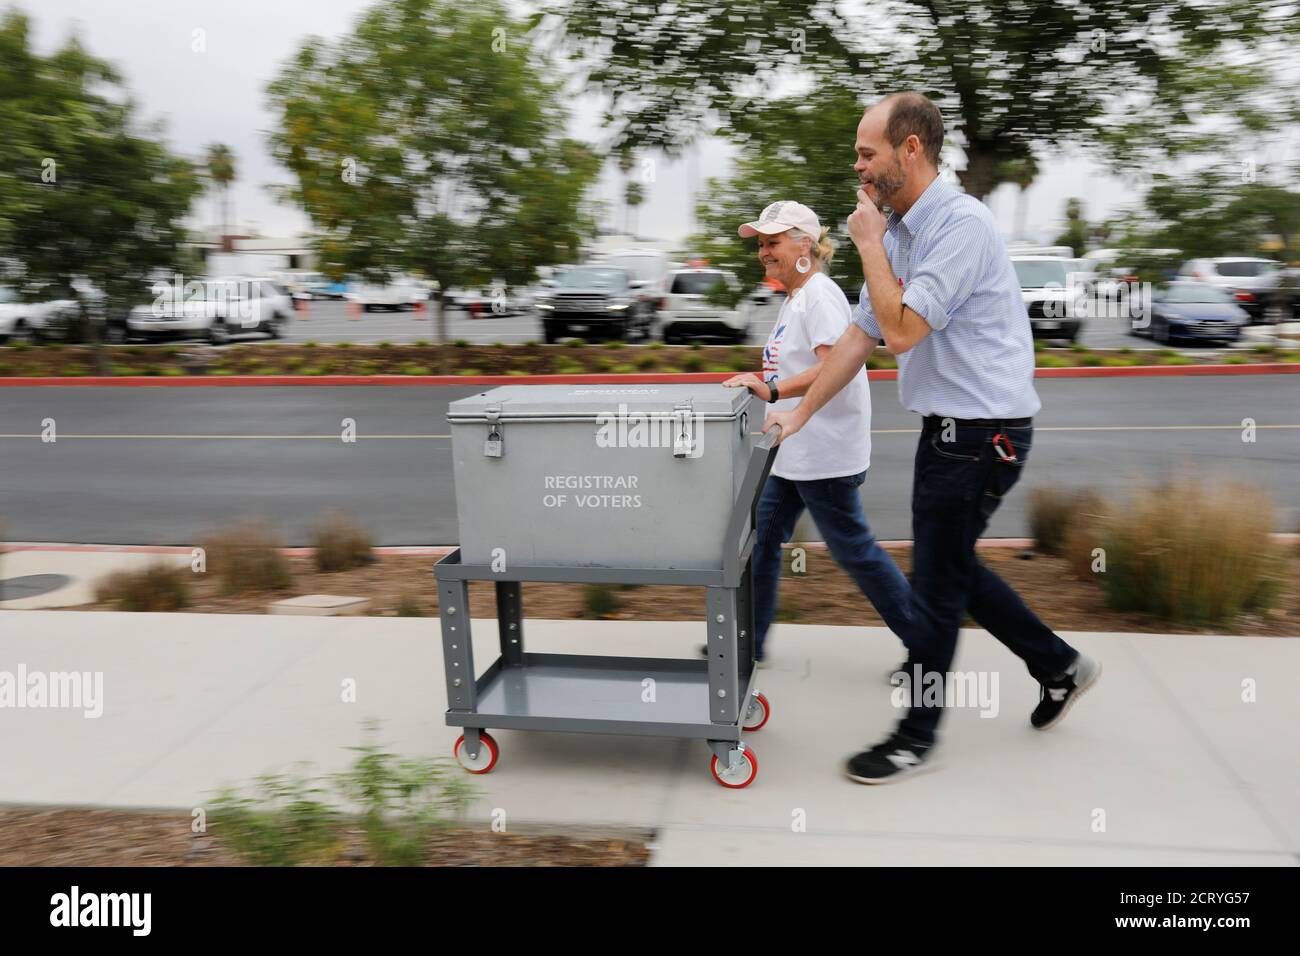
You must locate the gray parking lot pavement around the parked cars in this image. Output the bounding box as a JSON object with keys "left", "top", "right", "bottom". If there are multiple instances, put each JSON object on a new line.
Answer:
{"left": 202, "top": 300, "right": 1271, "bottom": 352}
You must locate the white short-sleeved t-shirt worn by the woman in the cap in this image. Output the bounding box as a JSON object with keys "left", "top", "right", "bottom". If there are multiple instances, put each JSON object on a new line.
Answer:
{"left": 763, "top": 272, "right": 871, "bottom": 481}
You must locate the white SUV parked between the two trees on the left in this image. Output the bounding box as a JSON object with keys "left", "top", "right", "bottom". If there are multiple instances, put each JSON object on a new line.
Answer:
{"left": 120, "top": 278, "right": 294, "bottom": 345}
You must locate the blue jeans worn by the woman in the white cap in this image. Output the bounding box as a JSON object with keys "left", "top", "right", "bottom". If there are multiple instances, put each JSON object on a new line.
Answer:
{"left": 753, "top": 471, "right": 911, "bottom": 658}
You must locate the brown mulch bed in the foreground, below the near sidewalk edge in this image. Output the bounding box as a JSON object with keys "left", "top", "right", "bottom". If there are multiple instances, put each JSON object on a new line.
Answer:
{"left": 0, "top": 808, "right": 650, "bottom": 866}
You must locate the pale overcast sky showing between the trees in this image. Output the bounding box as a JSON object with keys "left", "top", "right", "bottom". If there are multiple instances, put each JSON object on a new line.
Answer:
{"left": 17, "top": 0, "right": 1289, "bottom": 251}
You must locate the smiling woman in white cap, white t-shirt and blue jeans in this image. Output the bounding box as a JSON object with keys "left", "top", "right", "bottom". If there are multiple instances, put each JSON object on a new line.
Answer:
{"left": 724, "top": 202, "right": 911, "bottom": 662}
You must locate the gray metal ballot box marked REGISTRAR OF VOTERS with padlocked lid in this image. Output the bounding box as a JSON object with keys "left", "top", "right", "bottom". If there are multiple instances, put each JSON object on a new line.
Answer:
{"left": 447, "top": 384, "right": 762, "bottom": 570}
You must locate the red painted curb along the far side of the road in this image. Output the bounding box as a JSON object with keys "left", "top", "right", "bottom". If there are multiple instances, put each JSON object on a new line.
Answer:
{"left": 0, "top": 362, "right": 1300, "bottom": 388}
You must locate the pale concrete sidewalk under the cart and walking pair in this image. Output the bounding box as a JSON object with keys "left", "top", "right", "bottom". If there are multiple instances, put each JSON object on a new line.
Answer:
{"left": 0, "top": 611, "right": 1300, "bottom": 866}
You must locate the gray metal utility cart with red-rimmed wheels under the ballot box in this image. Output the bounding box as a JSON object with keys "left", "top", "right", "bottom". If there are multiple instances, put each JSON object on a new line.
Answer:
{"left": 434, "top": 428, "right": 780, "bottom": 790}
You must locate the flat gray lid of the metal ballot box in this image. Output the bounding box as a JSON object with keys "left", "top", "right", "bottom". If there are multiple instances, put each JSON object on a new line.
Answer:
{"left": 447, "top": 382, "right": 750, "bottom": 421}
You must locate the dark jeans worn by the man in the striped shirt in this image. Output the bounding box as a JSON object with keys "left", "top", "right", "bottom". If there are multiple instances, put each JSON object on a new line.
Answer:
{"left": 900, "top": 419, "right": 1078, "bottom": 741}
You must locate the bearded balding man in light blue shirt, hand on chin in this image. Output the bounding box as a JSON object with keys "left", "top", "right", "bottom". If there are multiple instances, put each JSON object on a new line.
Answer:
{"left": 763, "top": 92, "right": 1101, "bottom": 783}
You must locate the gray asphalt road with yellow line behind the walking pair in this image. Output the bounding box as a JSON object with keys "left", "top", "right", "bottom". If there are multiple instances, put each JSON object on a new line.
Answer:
{"left": 0, "top": 376, "right": 1300, "bottom": 545}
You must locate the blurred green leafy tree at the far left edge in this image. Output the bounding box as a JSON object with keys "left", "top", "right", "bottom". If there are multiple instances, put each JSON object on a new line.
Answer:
{"left": 0, "top": 12, "right": 202, "bottom": 364}
